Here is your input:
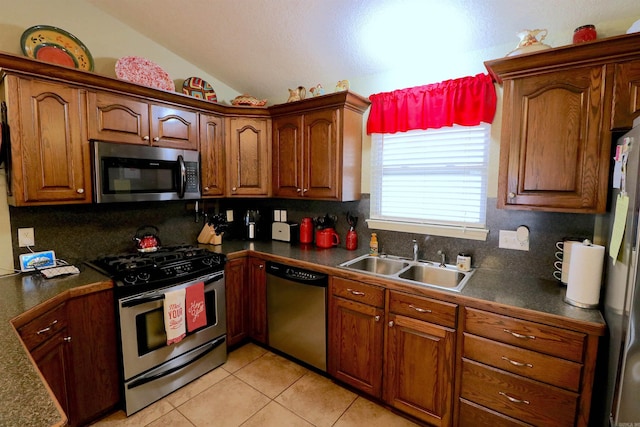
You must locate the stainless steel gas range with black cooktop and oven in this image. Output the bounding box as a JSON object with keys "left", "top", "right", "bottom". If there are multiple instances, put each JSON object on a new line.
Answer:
{"left": 89, "top": 246, "right": 227, "bottom": 415}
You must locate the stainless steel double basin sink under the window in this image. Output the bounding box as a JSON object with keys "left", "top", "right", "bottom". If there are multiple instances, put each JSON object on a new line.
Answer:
{"left": 339, "top": 255, "right": 473, "bottom": 292}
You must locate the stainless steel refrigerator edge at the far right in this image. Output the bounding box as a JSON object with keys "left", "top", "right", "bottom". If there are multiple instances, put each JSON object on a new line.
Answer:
{"left": 603, "top": 118, "right": 640, "bottom": 427}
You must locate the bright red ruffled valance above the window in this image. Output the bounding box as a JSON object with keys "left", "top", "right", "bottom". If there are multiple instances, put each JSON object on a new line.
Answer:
{"left": 367, "top": 74, "right": 496, "bottom": 134}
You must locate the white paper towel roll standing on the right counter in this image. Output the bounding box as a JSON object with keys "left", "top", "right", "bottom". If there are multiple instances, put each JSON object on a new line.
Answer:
{"left": 564, "top": 244, "right": 605, "bottom": 308}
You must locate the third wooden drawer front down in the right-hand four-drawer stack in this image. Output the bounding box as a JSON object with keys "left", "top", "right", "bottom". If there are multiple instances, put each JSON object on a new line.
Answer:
{"left": 460, "top": 359, "right": 578, "bottom": 427}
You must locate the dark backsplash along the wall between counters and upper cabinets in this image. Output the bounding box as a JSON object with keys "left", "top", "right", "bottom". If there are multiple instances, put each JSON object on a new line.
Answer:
{"left": 10, "top": 194, "right": 595, "bottom": 279}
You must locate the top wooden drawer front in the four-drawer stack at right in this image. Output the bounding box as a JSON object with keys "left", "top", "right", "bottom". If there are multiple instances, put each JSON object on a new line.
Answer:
{"left": 464, "top": 308, "right": 586, "bottom": 362}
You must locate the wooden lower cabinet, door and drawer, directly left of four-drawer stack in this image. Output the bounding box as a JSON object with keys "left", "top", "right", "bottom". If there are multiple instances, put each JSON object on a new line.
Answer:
{"left": 383, "top": 291, "right": 457, "bottom": 426}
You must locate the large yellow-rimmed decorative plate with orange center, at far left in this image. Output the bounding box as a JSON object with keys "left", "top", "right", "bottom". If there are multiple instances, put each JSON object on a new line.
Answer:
{"left": 20, "top": 25, "right": 93, "bottom": 71}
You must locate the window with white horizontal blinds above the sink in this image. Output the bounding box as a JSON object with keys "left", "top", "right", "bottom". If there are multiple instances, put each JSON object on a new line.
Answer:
{"left": 370, "top": 123, "right": 490, "bottom": 239}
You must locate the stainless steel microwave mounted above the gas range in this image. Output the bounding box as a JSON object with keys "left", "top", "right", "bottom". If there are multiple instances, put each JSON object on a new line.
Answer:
{"left": 91, "top": 141, "right": 201, "bottom": 203}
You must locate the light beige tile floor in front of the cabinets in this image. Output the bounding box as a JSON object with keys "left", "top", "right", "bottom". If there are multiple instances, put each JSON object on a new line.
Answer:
{"left": 93, "top": 344, "right": 416, "bottom": 427}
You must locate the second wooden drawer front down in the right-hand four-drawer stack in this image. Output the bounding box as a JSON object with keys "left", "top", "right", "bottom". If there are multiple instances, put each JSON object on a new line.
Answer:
{"left": 463, "top": 333, "right": 582, "bottom": 392}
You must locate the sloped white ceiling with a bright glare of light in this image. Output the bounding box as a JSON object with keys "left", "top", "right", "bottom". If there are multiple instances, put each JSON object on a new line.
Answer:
{"left": 88, "top": 0, "right": 640, "bottom": 98}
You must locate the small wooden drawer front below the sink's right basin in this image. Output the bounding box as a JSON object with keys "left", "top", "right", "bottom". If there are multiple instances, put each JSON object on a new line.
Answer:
{"left": 389, "top": 291, "right": 458, "bottom": 328}
